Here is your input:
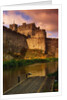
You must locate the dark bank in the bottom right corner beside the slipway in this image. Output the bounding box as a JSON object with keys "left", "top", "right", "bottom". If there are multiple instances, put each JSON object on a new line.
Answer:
{"left": 43, "top": 71, "right": 58, "bottom": 92}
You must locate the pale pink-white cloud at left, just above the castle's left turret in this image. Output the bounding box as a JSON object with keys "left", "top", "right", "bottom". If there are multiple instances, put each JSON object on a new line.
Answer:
{"left": 3, "top": 12, "right": 27, "bottom": 25}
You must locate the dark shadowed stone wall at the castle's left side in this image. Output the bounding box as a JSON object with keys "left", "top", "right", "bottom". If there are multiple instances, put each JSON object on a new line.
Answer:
{"left": 3, "top": 27, "right": 28, "bottom": 53}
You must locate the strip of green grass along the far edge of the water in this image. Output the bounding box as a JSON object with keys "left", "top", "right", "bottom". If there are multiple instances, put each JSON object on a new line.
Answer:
{"left": 3, "top": 58, "right": 58, "bottom": 70}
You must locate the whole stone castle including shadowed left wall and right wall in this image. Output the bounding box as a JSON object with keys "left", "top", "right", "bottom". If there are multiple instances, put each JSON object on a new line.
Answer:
{"left": 3, "top": 23, "right": 58, "bottom": 58}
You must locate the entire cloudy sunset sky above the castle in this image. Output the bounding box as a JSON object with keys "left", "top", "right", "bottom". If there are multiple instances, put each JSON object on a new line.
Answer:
{"left": 3, "top": 9, "right": 58, "bottom": 38}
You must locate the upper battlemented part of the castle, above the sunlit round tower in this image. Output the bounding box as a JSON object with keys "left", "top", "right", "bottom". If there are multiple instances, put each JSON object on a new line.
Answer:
{"left": 9, "top": 23, "right": 46, "bottom": 37}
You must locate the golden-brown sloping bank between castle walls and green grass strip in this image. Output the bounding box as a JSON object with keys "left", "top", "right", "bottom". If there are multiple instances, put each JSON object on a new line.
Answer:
{"left": 3, "top": 49, "right": 58, "bottom": 61}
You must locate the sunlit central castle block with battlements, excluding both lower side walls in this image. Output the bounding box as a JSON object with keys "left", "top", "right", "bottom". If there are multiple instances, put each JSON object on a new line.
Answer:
{"left": 10, "top": 23, "right": 46, "bottom": 52}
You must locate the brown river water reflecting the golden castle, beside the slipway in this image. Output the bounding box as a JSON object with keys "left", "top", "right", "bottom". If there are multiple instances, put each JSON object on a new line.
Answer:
{"left": 3, "top": 62, "right": 58, "bottom": 92}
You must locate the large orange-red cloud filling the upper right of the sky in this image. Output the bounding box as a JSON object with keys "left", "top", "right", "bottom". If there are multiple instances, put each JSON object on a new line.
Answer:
{"left": 20, "top": 9, "right": 58, "bottom": 32}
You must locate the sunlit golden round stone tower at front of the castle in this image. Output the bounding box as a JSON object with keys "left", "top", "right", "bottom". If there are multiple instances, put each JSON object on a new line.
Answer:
{"left": 27, "top": 31, "right": 46, "bottom": 53}
